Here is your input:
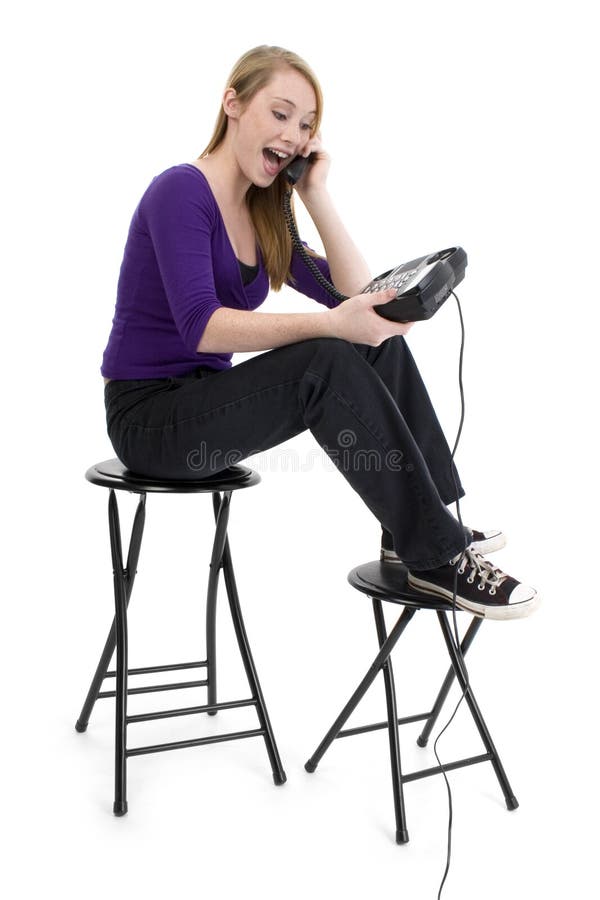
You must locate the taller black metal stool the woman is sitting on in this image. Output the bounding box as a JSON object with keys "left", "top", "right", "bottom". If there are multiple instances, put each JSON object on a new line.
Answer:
{"left": 75, "top": 459, "right": 286, "bottom": 816}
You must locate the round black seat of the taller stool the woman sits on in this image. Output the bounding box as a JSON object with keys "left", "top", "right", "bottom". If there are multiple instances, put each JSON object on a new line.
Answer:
{"left": 85, "top": 459, "right": 261, "bottom": 494}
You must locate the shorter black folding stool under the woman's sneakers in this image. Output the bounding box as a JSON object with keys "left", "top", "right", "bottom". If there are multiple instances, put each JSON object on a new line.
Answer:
{"left": 305, "top": 561, "right": 519, "bottom": 844}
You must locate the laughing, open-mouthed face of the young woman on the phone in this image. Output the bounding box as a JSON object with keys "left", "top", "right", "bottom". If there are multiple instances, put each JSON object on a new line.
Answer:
{"left": 224, "top": 66, "right": 317, "bottom": 187}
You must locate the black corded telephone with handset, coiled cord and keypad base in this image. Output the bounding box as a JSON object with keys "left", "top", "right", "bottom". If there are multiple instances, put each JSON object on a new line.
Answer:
{"left": 283, "top": 153, "right": 467, "bottom": 322}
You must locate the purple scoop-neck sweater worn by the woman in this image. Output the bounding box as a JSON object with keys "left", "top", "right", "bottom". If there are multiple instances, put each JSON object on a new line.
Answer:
{"left": 100, "top": 163, "right": 337, "bottom": 379}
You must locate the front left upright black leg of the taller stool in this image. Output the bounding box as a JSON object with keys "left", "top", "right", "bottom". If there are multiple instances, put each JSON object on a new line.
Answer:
{"left": 108, "top": 490, "right": 127, "bottom": 816}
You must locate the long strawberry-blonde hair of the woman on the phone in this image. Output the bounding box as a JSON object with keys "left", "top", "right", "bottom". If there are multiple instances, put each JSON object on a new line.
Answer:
{"left": 198, "top": 44, "right": 323, "bottom": 291}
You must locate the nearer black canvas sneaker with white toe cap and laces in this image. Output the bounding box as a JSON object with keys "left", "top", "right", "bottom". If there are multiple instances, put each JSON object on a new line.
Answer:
{"left": 408, "top": 548, "right": 540, "bottom": 619}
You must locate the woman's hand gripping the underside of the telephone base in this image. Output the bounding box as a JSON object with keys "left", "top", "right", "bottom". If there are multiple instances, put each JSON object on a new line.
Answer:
{"left": 327, "top": 288, "right": 414, "bottom": 347}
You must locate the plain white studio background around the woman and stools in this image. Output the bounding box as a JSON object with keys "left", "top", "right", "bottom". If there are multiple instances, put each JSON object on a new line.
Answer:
{"left": 0, "top": 0, "right": 599, "bottom": 900}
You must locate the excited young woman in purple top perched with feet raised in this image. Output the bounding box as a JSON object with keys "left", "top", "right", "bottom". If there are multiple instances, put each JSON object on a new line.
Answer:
{"left": 101, "top": 46, "right": 538, "bottom": 618}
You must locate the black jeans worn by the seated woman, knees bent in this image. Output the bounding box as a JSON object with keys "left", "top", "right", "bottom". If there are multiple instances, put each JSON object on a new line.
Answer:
{"left": 105, "top": 337, "right": 468, "bottom": 569}
